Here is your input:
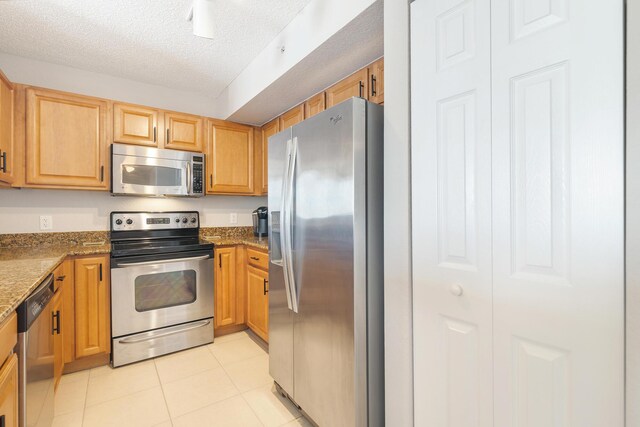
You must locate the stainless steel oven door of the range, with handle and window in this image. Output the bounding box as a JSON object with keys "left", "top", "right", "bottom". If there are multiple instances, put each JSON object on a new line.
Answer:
{"left": 111, "top": 250, "right": 213, "bottom": 337}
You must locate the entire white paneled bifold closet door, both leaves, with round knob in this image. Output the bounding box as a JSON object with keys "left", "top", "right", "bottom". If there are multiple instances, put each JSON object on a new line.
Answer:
{"left": 411, "top": 0, "right": 624, "bottom": 427}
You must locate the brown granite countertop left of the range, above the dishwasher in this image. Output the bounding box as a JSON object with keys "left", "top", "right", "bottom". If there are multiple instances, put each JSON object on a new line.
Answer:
{"left": 0, "top": 243, "right": 111, "bottom": 322}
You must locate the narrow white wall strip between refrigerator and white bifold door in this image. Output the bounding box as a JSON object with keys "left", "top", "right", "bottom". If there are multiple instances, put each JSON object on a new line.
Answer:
{"left": 384, "top": 0, "right": 414, "bottom": 426}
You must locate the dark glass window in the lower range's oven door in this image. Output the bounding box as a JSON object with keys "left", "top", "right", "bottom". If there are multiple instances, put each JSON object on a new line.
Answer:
{"left": 135, "top": 270, "right": 197, "bottom": 312}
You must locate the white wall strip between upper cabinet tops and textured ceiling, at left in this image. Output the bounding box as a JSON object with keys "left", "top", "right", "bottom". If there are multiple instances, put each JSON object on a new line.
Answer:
{"left": 0, "top": 52, "right": 216, "bottom": 117}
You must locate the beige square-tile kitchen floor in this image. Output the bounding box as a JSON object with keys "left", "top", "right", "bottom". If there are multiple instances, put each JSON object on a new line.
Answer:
{"left": 53, "top": 332, "right": 311, "bottom": 427}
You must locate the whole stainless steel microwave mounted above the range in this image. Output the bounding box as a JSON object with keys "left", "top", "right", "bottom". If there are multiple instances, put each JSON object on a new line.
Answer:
{"left": 111, "top": 144, "right": 205, "bottom": 197}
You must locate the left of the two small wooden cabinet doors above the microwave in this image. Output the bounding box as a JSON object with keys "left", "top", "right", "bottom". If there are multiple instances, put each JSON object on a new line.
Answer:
{"left": 113, "top": 104, "right": 160, "bottom": 147}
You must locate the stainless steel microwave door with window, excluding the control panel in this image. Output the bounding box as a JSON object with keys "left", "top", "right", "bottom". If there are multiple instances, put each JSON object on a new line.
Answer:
{"left": 111, "top": 154, "right": 192, "bottom": 196}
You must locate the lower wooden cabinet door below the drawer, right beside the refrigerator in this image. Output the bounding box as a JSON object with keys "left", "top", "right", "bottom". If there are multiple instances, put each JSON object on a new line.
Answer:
{"left": 247, "top": 266, "right": 269, "bottom": 342}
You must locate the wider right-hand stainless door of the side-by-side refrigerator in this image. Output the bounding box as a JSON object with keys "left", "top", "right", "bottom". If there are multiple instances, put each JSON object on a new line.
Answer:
{"left": 292, "top": 100, "right": 366, "bottom": 427}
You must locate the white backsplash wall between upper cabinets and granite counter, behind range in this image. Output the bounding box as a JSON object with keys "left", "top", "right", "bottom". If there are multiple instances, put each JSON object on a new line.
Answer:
{"left": 0, "top": 189, "right": 267, "bottom": 234}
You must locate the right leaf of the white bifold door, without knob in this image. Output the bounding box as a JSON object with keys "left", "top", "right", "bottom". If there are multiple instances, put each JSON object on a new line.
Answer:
{"left": 491, "top": 0, "right": 624, "bottom": 427}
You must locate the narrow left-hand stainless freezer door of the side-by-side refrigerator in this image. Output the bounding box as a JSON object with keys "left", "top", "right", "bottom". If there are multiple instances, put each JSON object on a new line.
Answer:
{"left": 268, "top": 129, "right": 293, "bottom": 396}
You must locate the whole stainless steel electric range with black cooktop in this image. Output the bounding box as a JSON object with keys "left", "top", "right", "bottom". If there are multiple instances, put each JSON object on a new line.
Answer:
{"left": 111, "top": 212, "right": 214, "bottom": 367}
